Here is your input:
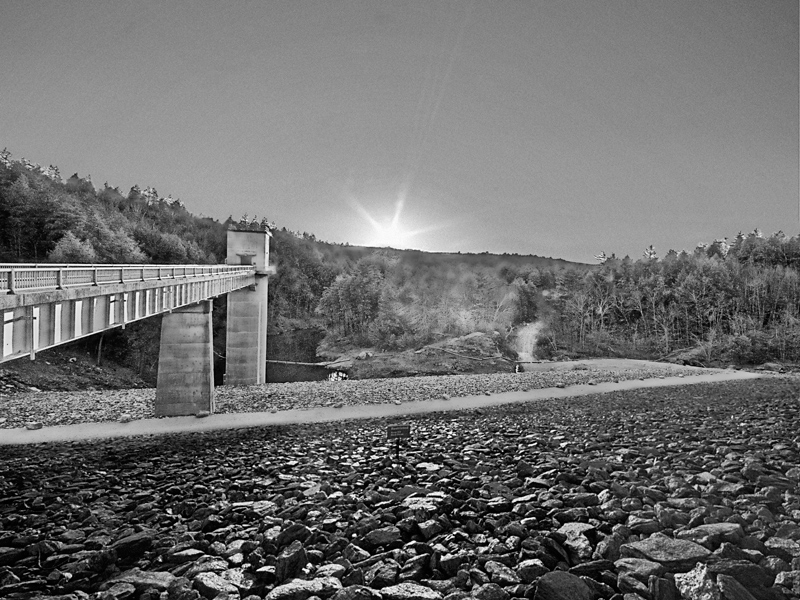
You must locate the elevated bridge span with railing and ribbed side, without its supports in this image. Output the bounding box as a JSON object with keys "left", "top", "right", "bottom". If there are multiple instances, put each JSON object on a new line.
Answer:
{"left": 0, "top": 263, "right": 256, "bottom": 362}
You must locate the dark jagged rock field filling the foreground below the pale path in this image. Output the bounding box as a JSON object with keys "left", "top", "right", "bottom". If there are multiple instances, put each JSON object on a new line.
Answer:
{"left": 0, "top": 373, "right": 800, "bottom": 600}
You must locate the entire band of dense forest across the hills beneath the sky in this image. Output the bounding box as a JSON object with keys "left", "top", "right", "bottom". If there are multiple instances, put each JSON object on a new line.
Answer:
{"left": 0, "top": 150, "right": 800, "bottom": 376}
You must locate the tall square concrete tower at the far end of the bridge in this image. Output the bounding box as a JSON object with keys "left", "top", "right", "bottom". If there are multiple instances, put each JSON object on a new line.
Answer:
{"left": 225, "top": 230, "right": 270, "bottom": 385}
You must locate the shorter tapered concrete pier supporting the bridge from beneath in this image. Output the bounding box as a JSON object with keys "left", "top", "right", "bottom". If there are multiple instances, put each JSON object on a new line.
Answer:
{"left": 156, "top": 300, "right": 214, "bottom": 417}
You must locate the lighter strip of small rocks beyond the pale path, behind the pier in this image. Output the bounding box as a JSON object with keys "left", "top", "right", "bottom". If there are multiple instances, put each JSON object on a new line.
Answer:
{"left": 0, "top": 365, "right": 712, "bottom": 429}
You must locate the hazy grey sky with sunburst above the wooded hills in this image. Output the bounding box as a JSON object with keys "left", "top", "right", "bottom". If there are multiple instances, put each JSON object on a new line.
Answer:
{"left": 0, "top": 0, "right": 800, "bottom": 262}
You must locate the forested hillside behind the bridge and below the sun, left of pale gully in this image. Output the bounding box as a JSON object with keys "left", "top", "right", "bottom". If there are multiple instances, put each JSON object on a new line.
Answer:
{"left": 0, "top": 150, "right": 588, "bottom": 376}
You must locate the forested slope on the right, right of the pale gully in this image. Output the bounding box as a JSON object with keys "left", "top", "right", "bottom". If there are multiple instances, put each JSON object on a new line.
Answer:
{"left": 539, "top": 230, "right": 800, "bottom": 364}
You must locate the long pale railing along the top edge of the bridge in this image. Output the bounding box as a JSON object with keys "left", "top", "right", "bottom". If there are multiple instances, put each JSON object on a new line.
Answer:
{"left": 0, "top": 263, "right": 254, "bottom": 294}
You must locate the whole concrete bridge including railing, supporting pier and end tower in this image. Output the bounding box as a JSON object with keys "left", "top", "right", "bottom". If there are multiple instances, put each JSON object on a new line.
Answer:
{"left": 0, "top": 230, "right": 273, "bottom": 416}
